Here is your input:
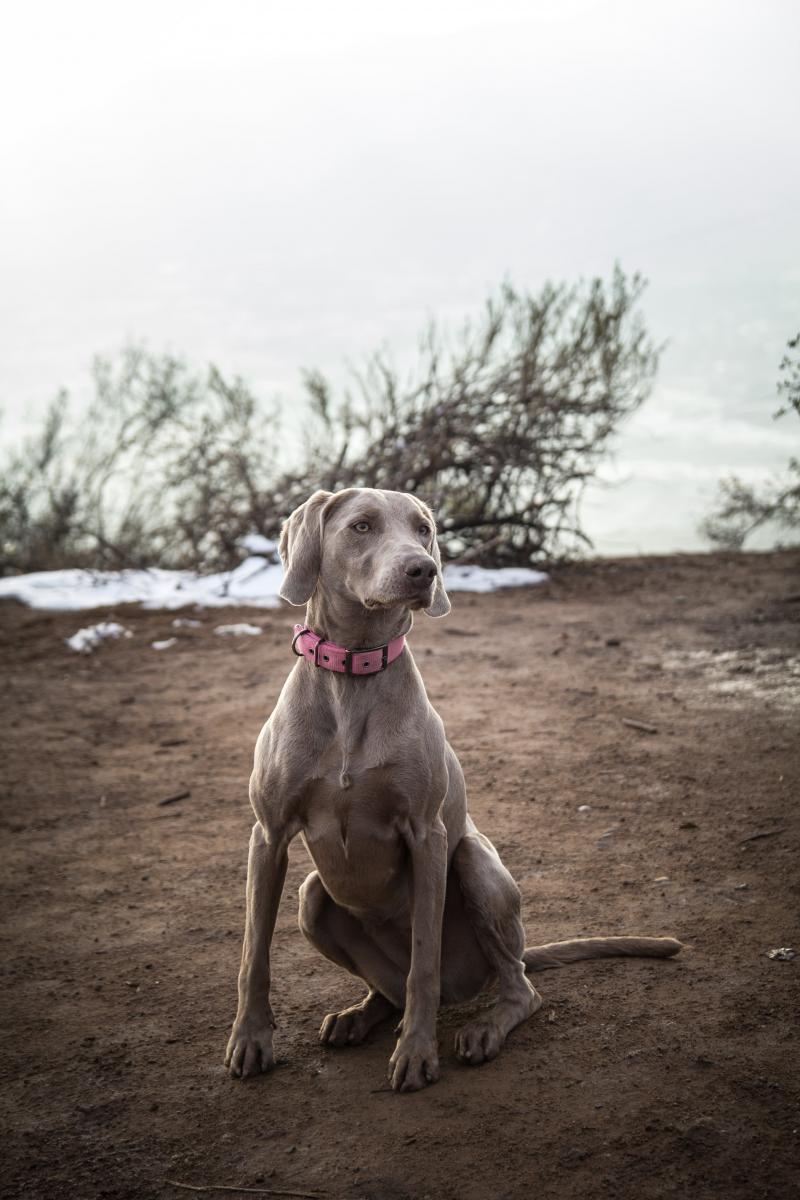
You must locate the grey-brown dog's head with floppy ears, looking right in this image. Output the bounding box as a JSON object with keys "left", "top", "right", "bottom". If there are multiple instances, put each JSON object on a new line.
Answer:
{"left": 279, "top": 487, "right": 450, "bottom": 617}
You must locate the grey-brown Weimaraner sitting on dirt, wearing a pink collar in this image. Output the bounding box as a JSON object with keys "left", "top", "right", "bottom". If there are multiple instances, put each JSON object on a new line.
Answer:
{"left": 225, "top": 488, "right": 680, "bottom": 1092}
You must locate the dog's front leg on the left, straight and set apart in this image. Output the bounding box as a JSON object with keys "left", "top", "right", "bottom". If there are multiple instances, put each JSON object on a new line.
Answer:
{"left": 225, "top": 823, "right": 289, "bottom": 1078}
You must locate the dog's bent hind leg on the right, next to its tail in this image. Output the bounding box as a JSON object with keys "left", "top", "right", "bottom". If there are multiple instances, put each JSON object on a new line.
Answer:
{"left": 443, "top": 822, "right": 542, "bottom": 1066}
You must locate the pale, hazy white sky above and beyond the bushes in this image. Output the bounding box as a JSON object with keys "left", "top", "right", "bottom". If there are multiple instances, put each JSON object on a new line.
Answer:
{"left": 0, "top": 0, "right": 800, "bottom": 554}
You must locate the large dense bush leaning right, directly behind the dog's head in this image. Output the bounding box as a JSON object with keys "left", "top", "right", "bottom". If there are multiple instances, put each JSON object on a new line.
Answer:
{"left": 301, "top": 268, "right": 657, "bottom": 563}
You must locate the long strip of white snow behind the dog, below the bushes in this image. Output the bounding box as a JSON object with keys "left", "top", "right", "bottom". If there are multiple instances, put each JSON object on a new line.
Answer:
{"left": 0, "top": 554, "right": 548, "bottom": 612}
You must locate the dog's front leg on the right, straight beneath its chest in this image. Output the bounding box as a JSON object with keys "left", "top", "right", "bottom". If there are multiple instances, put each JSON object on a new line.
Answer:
{"left": 389, "top": 817, "right": 447, "bottom": 1092}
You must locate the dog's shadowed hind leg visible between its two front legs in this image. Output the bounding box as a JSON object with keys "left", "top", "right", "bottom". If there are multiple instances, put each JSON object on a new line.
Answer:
{"left": 299, "top": 871, "right": 408, "bottom": 1046}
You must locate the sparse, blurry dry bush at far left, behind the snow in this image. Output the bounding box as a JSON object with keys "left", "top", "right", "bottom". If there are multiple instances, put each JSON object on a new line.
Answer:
{"left": 0, "top": 347, "right": 276, "bottom": 574}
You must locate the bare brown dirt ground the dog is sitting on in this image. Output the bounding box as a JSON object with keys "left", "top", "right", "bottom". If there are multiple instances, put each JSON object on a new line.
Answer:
{"left": 0, "top": 552, "right": 800, "bottom": 1200}
